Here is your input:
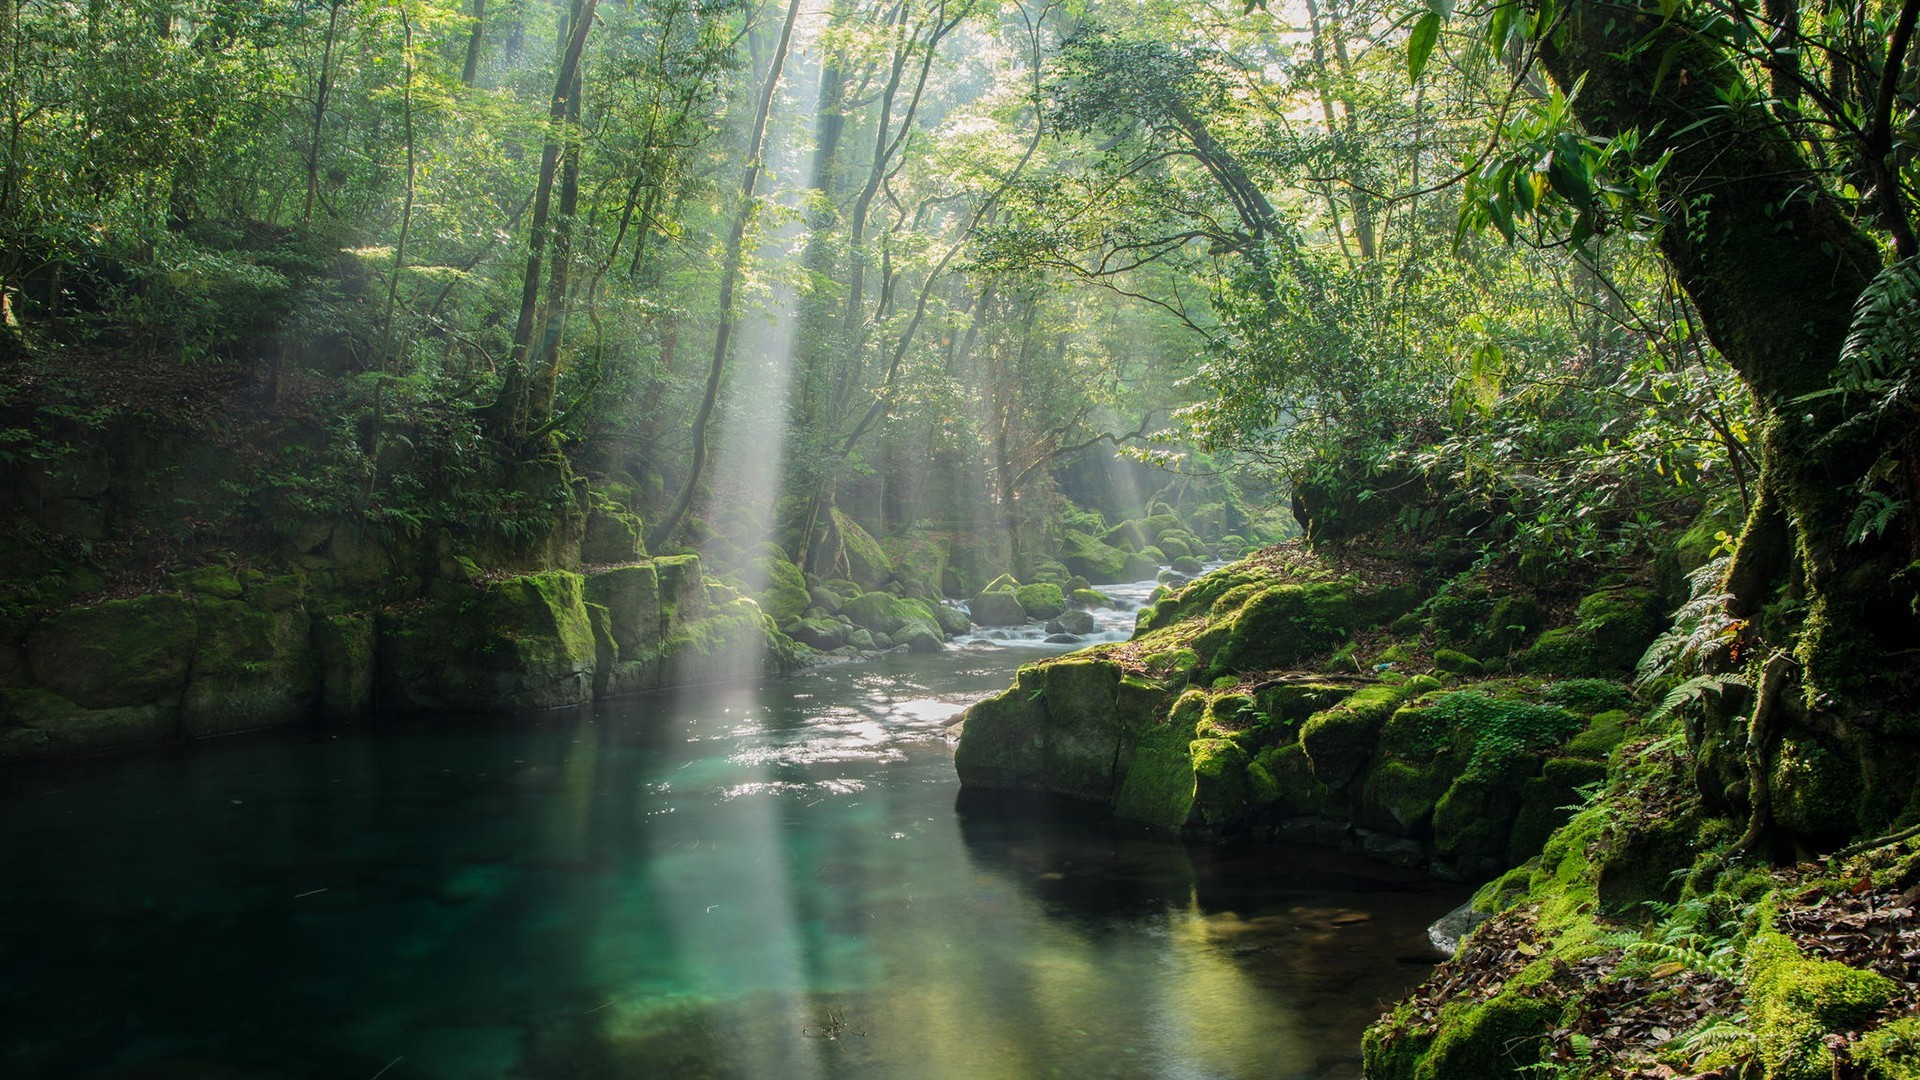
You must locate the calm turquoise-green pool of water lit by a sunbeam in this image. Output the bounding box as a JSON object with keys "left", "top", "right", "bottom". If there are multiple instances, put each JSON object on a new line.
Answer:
{"left": 0, "top": 648, "right": 1459, "bottom": 1080}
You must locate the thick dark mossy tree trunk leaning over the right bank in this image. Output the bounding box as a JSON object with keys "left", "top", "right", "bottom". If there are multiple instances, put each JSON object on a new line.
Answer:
{"left": 1542, "top": 2, "right": 1920, "bottom": 830}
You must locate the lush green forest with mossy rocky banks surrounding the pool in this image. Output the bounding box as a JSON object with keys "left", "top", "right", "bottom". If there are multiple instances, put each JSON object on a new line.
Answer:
{"left": 0, "top": 0, "right": 1920, "bottom": 1080}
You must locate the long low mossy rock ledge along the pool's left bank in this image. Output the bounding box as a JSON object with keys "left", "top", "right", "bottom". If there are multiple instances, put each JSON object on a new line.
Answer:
{"left": 0, "top": 555, "right": 797, "bottom": 761}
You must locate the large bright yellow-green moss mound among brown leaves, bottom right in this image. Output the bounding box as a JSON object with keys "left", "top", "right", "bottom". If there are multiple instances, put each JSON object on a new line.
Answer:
{"left": 1743, "top": 905, "right": 1899, "bottom": 1080}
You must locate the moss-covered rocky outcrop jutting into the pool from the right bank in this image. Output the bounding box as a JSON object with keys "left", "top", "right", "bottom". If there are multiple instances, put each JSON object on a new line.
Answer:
{"left": 954, "top": 550, "right": 1632, "bottom": 876}
